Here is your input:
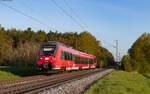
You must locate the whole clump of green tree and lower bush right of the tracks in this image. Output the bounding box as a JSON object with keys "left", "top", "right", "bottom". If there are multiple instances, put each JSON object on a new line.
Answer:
{"left": 121, "top": 33, "right": 150, "bottom": 73}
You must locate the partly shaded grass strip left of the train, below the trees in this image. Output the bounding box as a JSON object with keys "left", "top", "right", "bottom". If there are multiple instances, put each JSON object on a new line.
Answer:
{"left": 0, "top": 66, "right": 37, "bottom": 80}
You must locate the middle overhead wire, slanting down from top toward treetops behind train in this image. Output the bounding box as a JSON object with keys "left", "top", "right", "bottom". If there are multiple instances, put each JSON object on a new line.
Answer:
{"left": 51, "top": 0, "right": 86, "bottom": 31}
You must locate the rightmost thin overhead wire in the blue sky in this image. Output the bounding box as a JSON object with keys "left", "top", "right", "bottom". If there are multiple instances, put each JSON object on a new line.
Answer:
{"left": 64, "top": 0, "right": 88, "bottom": 27}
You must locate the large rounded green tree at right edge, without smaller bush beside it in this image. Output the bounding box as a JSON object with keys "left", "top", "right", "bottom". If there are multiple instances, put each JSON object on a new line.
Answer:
{"left": 129, "top": 33, "right": 150, "bottom": 73}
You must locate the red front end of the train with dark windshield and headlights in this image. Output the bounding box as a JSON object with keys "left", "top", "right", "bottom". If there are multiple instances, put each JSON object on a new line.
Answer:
{"left": 36, "top": 42, "right": 56, "bottom": 72}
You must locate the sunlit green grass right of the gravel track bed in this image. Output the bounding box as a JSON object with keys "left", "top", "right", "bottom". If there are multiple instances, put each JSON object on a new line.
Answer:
{"left": 84, "top": 71, "right": 150, "bottom": 94}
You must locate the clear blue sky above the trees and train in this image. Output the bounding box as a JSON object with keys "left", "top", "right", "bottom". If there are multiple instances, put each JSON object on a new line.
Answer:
{"left": 0, "top": 0, "right": 150, "bottom": 60}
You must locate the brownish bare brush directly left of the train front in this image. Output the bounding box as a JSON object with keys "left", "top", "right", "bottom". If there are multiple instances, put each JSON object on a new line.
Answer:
{"left": 8, "top": 43, "right": 39, "bottom": 67}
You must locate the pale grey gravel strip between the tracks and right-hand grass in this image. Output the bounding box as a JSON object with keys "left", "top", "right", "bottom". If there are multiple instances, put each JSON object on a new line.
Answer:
{"left": 39, "top": 69, "right": 114, "bottom": 94}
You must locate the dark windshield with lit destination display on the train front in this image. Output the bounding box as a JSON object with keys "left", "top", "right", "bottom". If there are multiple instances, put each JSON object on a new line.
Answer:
{"left": 41, "top": 46, "right": 56, "bottom": 56}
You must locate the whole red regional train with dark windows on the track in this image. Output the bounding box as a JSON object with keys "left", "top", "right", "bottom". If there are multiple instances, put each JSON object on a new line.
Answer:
{"left": 36, "top": 41, "right": 96, "bottom": 71}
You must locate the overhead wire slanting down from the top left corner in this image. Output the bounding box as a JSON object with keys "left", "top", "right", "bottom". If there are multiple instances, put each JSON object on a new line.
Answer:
{"left": 0, "top": 2, "right": 55, "bottom": 30}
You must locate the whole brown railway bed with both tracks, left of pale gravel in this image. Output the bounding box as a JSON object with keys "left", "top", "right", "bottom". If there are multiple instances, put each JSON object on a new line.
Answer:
{"left": 0, "top": 69, "right": 106, "bottom": 94}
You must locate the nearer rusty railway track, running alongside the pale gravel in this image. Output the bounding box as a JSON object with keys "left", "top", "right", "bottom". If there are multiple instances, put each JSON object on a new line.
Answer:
{"left": 0, "top": 69, "right": 103, "bottom": 94}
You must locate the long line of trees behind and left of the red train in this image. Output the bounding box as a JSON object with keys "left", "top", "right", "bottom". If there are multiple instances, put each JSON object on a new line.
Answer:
{"left": 0, "top": 26, "right": 114, "bottom": 67}
